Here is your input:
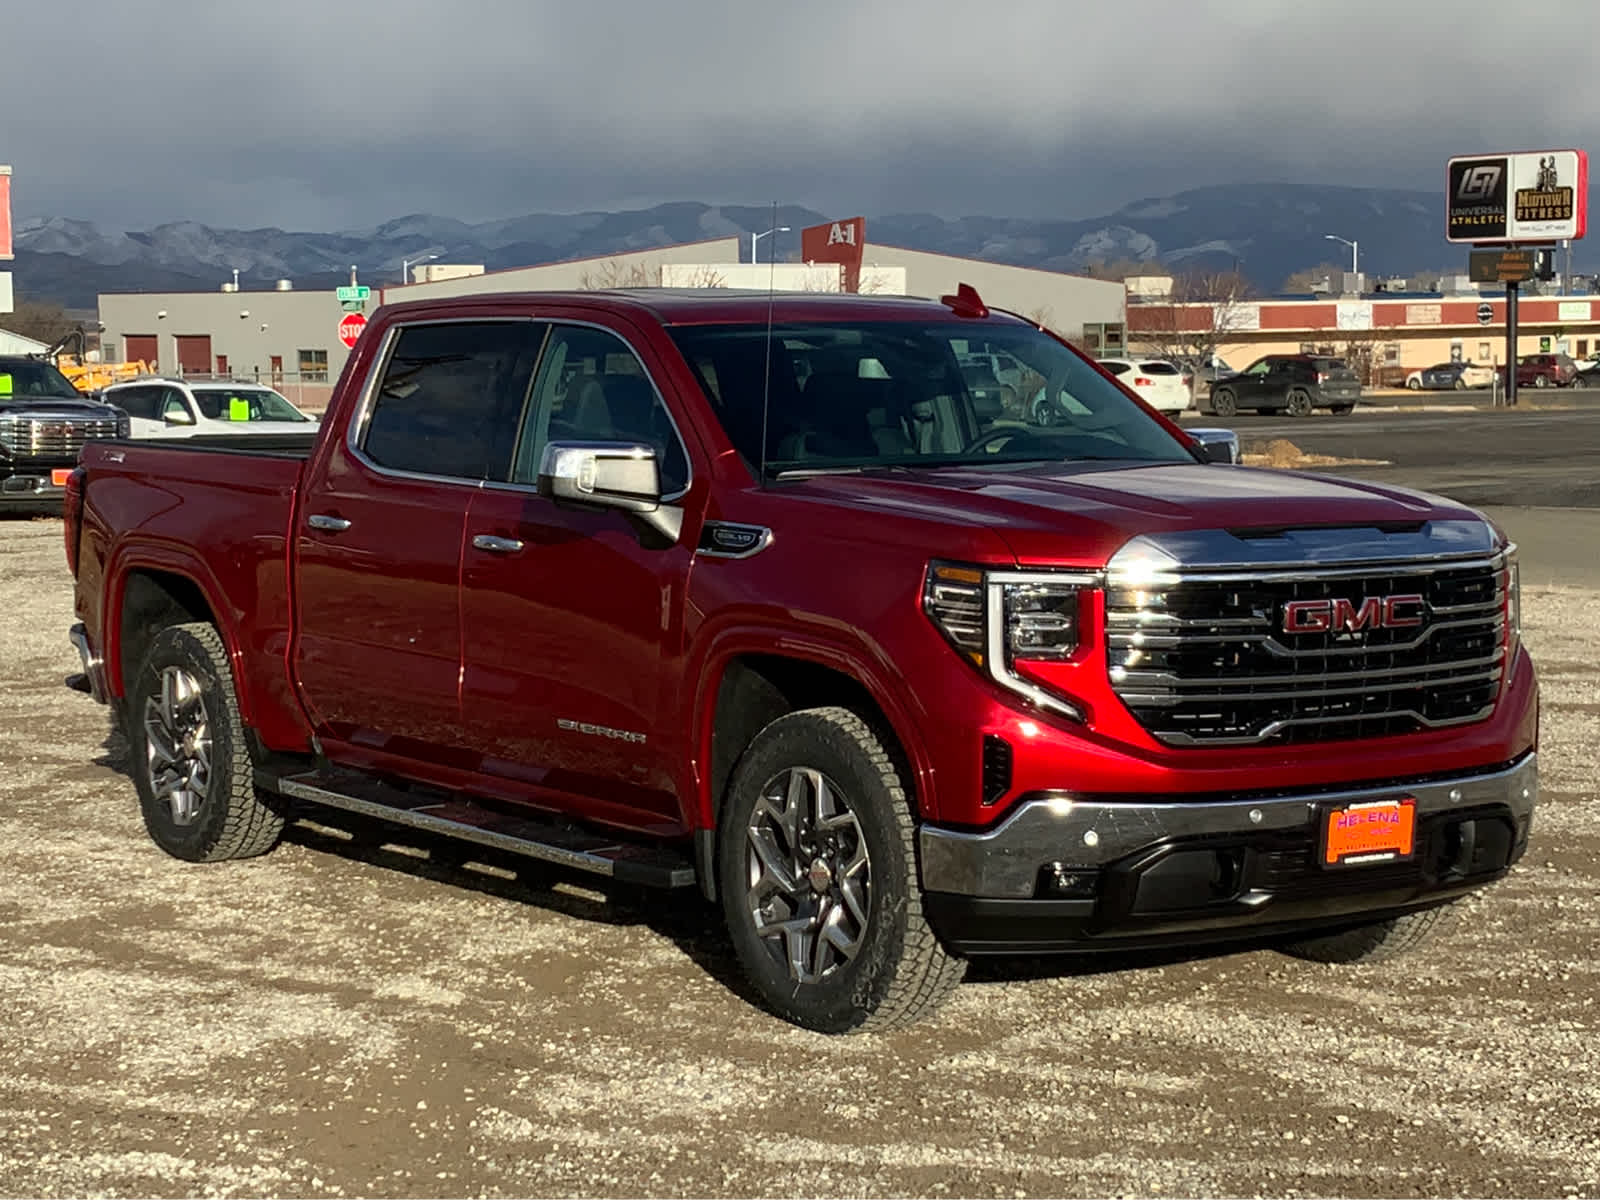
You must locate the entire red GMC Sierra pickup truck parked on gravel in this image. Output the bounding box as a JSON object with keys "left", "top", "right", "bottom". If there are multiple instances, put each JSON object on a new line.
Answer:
{"left": 66, "top": 288, "right": 1538, "bottom": 1032}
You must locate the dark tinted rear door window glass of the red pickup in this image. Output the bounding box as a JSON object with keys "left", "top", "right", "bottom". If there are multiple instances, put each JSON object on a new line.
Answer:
{"left": 362, "top": 322, "right": 546, "bottom": 480}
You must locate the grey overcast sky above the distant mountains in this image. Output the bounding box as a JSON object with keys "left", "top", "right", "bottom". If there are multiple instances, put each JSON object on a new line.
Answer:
{"left": 0, "top": 0, "right": 1600, "bottom": 230}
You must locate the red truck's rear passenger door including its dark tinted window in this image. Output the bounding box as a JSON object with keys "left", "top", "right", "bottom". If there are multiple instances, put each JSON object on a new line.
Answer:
{"left": 294, "top": 320, "right": 542, "bottom": 766}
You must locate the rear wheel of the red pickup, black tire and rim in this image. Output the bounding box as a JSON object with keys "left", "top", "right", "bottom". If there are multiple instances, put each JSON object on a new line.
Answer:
{"left": 126, "top": 622, "right": 283, "bottom": 862}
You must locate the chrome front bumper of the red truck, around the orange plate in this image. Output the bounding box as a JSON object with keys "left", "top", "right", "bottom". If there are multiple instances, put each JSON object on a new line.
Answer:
{"left": 918, "top": 754, "right": 1539, "bottom": 899}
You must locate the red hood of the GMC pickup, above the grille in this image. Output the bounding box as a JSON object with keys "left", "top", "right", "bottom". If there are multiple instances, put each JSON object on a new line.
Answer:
{"left": 797, "top": 462, "right": 1480, "bottom": 568}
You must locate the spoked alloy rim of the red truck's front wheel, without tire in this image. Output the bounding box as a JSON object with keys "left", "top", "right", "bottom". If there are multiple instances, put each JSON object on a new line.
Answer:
{"left": 746, "top": 766, "right": 872, "bottom": 984}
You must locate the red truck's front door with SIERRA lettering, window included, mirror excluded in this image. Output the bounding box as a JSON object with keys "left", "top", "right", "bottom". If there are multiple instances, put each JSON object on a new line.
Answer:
{"left": 461, "top": 322, "right": 691, "bottom": 834}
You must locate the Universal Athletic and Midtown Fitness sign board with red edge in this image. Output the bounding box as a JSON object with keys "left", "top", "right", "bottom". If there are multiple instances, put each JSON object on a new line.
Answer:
{"left": 1445, "top": 150, "right": 1589, "bottom": 243}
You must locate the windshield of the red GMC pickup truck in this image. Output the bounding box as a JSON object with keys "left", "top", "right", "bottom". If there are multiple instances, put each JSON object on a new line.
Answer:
{"left": 670, "top": 322, "right": 1194, "bottom": 477}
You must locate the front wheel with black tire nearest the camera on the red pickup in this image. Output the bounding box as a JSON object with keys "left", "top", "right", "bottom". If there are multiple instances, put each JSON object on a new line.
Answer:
{"left": 717, "top": 707, "right": 966, "bottom": 1034}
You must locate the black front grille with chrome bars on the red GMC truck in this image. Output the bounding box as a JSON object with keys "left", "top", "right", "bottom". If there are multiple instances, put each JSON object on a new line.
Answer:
{"left": 1106, "top": 558, "right": 1509, "bottom": 746}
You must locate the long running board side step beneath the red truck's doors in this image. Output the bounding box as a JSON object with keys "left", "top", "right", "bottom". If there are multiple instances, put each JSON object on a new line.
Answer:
{"left": 256, "top": 768, "right": 694, "bottom": 888}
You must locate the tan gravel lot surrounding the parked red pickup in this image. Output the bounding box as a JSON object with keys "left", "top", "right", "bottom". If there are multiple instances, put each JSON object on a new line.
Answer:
{"left": 0, "top": 520, "right": 1600, "bottom": 1197}
